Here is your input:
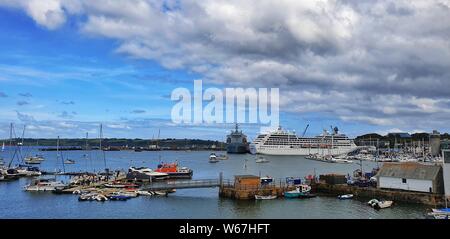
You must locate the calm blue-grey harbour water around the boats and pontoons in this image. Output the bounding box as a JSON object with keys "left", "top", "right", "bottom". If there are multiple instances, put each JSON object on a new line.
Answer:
{"left": 0, "top": 149, "right": 427, "bottom": 218}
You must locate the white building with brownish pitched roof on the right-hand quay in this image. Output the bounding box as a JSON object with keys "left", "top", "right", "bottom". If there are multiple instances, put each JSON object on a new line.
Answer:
{"left": 377, "top": 162, "right": 444, "bottom": 194}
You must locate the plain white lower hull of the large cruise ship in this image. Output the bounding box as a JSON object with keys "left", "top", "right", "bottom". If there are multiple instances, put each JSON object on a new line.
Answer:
{"left": 250, "top": 146, "right": 358, "bottom": 156}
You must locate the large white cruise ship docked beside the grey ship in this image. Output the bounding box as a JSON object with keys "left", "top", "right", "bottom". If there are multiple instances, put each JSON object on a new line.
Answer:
{"left": 250, "top": 127, "right": 358, "bottom": 155}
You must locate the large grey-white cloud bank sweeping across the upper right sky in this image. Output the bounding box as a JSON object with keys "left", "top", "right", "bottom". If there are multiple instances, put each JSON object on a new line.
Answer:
{"left": 0, "top": 0, "right": 450, "bottom": 133}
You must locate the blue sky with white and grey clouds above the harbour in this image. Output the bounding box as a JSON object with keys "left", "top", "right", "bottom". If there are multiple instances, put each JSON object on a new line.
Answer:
{"left": 0, "top": 0, "right": 450, "bottom": 140}
